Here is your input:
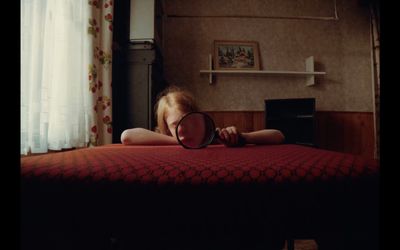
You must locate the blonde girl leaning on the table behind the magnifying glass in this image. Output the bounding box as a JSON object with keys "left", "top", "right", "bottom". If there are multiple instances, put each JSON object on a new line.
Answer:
{"left": 121, "top": 86, "right": 285, "bottom": 147}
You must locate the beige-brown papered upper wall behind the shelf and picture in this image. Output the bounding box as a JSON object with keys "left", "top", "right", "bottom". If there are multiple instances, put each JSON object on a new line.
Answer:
{"left": 163, "top": 0, "right": 373, "bottom": 112}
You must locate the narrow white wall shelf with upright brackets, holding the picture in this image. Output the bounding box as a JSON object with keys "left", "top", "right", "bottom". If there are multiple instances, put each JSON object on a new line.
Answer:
{"left": 200, "top": 55, "right": 326, "bottom": 86}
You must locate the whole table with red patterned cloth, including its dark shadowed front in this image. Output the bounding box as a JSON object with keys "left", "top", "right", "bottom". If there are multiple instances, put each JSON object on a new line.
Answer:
{"left": 21, "top": 144, "right": 380, "bottom": 249}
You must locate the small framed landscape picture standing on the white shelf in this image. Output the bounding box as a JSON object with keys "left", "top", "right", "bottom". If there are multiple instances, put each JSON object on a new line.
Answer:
{"left": 214, "top": 40, "right": 260, "bottom": 70}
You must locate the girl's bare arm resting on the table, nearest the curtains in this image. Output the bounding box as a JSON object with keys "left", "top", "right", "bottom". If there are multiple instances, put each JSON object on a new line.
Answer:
{"left": 121, "top": 128, "right": 178, "bottom": 145}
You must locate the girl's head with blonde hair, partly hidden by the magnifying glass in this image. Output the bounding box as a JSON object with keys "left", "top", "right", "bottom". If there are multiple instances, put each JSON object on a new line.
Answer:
{"left": 155, "top": 86, "right": 198, "bottom": 137}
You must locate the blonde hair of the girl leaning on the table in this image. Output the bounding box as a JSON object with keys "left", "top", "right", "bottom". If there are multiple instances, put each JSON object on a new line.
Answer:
{"left": 155, "top": 86, "right": 198, "bottom": 135}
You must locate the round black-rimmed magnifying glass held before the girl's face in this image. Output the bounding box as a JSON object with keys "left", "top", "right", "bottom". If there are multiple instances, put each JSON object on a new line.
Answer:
{"left": 175, "top": 112, "right": 246, "bottom": 149}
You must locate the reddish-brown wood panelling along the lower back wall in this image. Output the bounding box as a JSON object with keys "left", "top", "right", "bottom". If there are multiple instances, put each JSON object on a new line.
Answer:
{"left": 207, "top": 111, "right": 375, "bottom": 158}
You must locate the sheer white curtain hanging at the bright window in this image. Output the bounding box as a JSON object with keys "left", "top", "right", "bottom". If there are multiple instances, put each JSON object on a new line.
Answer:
{"left": 21, "top": 0, "right": 93, "bottom": 154}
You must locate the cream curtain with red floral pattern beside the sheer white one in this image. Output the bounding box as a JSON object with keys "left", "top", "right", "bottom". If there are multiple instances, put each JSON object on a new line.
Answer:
{"left": 87, "top": 0, "right": 114, "bottom": 146}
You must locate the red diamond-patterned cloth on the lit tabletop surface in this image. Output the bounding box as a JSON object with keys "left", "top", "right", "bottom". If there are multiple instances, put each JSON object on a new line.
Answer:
{"left": 21, "top": 144, "right": 379, "bottom": 184}
